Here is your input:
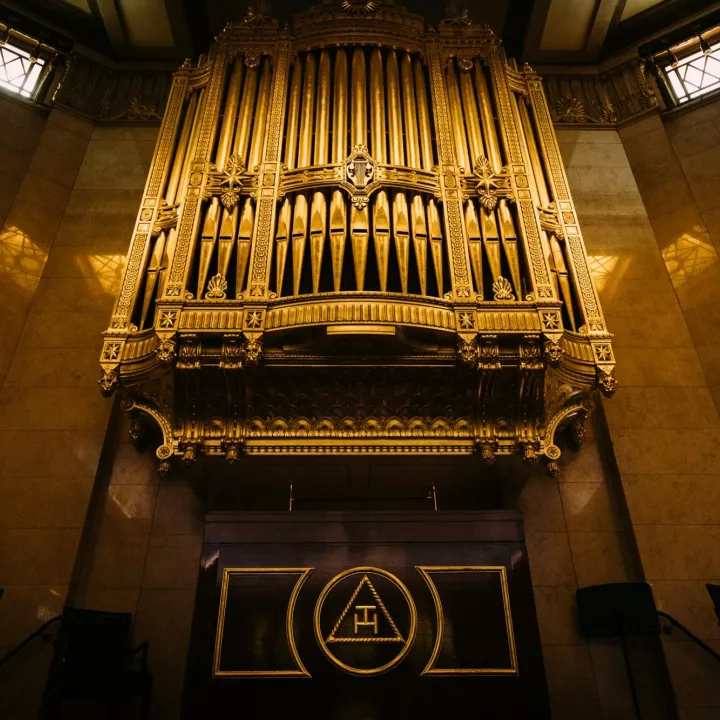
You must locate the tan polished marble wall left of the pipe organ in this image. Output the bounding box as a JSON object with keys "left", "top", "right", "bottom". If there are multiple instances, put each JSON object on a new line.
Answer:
{"left": 0, "top": 115, "right": 157, "bottom": 720}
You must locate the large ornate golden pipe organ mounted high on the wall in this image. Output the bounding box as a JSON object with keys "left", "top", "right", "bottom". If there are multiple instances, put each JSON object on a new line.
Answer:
{"left": 101, "top": 0, "right": 615, "bottom": 471}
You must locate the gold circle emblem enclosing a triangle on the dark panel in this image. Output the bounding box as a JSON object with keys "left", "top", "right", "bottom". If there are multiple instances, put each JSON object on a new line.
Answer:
{"left": 313, "top": 567, "right": 417, "bottom": 676}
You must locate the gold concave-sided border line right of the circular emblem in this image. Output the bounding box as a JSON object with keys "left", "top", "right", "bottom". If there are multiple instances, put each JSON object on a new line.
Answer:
{"left": 415, "top": 565, "right": 519, "bottom": 675}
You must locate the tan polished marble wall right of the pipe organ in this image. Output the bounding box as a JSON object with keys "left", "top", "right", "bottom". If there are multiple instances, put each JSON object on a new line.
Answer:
{"left": 559, "top": 124, "right": 720, "bottom": 720}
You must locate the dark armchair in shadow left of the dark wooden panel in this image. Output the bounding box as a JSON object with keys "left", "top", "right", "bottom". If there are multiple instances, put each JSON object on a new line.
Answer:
{"left": 41, "top": 607, "right": 152, "bottom": 720}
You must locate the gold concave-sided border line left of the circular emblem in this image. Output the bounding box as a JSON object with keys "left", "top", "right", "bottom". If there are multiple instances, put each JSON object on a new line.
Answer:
{"left": 213, "top": 568, "right": 315, "bottom": 678}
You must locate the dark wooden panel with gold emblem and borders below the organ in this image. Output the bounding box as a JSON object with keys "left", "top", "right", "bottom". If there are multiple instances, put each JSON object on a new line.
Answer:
{"left": 183, "top": 512, "right": 550, "bottom": 720}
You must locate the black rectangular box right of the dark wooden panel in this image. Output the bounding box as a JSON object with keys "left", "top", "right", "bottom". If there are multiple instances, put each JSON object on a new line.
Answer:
{"left": 577, "top": 583, "right": 660, "bottom": 638}
